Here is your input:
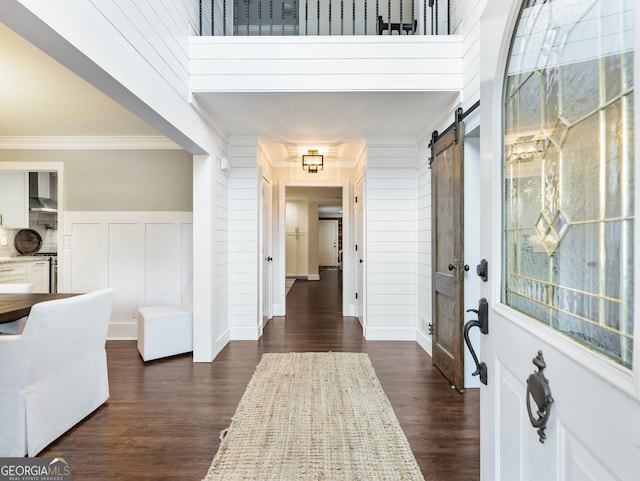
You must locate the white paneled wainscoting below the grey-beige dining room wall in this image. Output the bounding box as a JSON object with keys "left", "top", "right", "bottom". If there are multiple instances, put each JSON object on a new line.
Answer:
{"left": 59, "top": 212, "right": 193, "bottom": 339}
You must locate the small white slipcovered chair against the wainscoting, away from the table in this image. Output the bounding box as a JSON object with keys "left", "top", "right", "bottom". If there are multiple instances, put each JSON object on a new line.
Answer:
{"left": 138, "top": 275, "right": 193, "bottom": 362}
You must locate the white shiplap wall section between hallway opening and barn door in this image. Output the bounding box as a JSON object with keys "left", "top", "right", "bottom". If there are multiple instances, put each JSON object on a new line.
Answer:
{"left": 365, "top": 139, "right": 417, "bottom": 340}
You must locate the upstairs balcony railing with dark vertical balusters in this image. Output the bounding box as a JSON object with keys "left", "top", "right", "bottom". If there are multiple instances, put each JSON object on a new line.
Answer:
{"left": 200, "top": 0, "right": 451, "bottom": 36}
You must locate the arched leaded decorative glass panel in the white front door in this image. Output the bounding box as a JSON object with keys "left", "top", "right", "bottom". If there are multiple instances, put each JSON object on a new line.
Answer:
{"left": 503, "top": 0, "right": 635, "bottom": 368}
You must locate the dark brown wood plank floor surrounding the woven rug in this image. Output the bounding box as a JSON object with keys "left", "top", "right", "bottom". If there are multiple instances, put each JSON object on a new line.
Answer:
{"left": 40, "top": 270, "right": 480, "bottom": 481}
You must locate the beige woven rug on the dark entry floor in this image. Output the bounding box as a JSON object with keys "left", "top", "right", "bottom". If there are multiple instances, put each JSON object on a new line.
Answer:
{"left": 204, "top": 353, "right": 424, "bottom": 481}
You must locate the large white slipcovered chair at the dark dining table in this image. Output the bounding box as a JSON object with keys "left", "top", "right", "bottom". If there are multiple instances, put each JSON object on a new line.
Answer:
{"left": 0, "top": 289, "right": 115, "bottom": 457}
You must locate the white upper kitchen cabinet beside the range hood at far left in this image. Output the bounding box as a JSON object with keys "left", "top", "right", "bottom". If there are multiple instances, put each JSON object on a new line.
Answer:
{"left": 0, "top": 170, "right": 29, "bottom": 229}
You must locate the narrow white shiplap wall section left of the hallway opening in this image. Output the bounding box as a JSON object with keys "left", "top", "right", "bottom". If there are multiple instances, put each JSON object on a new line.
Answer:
{"left": 229, "top": 139, "right": 262, "bottom": 340}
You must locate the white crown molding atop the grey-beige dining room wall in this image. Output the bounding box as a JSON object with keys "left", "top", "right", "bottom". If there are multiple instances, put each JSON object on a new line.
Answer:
{"left": 0, "top": 135, "right": 182, "bottom": 150}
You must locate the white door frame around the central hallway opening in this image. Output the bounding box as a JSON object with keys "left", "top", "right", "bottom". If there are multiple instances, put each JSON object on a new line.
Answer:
{"left": 273, "top": 180, "right": 355, "bottom": 316}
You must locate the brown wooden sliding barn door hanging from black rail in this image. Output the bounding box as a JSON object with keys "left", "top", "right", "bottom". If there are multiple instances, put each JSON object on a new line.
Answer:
{"left": 431, "top": 123, "right": 464, "bottom": 390}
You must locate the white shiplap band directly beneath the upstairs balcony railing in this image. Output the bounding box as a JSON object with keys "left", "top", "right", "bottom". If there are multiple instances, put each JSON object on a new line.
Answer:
{"left": 189, "top": 35, "right": 463, "bottom": 92}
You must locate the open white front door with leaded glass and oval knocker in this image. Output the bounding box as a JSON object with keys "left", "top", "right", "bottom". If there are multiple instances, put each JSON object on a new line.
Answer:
{"left": 480, "top": 0, "right": 640, "bottom": 481}
